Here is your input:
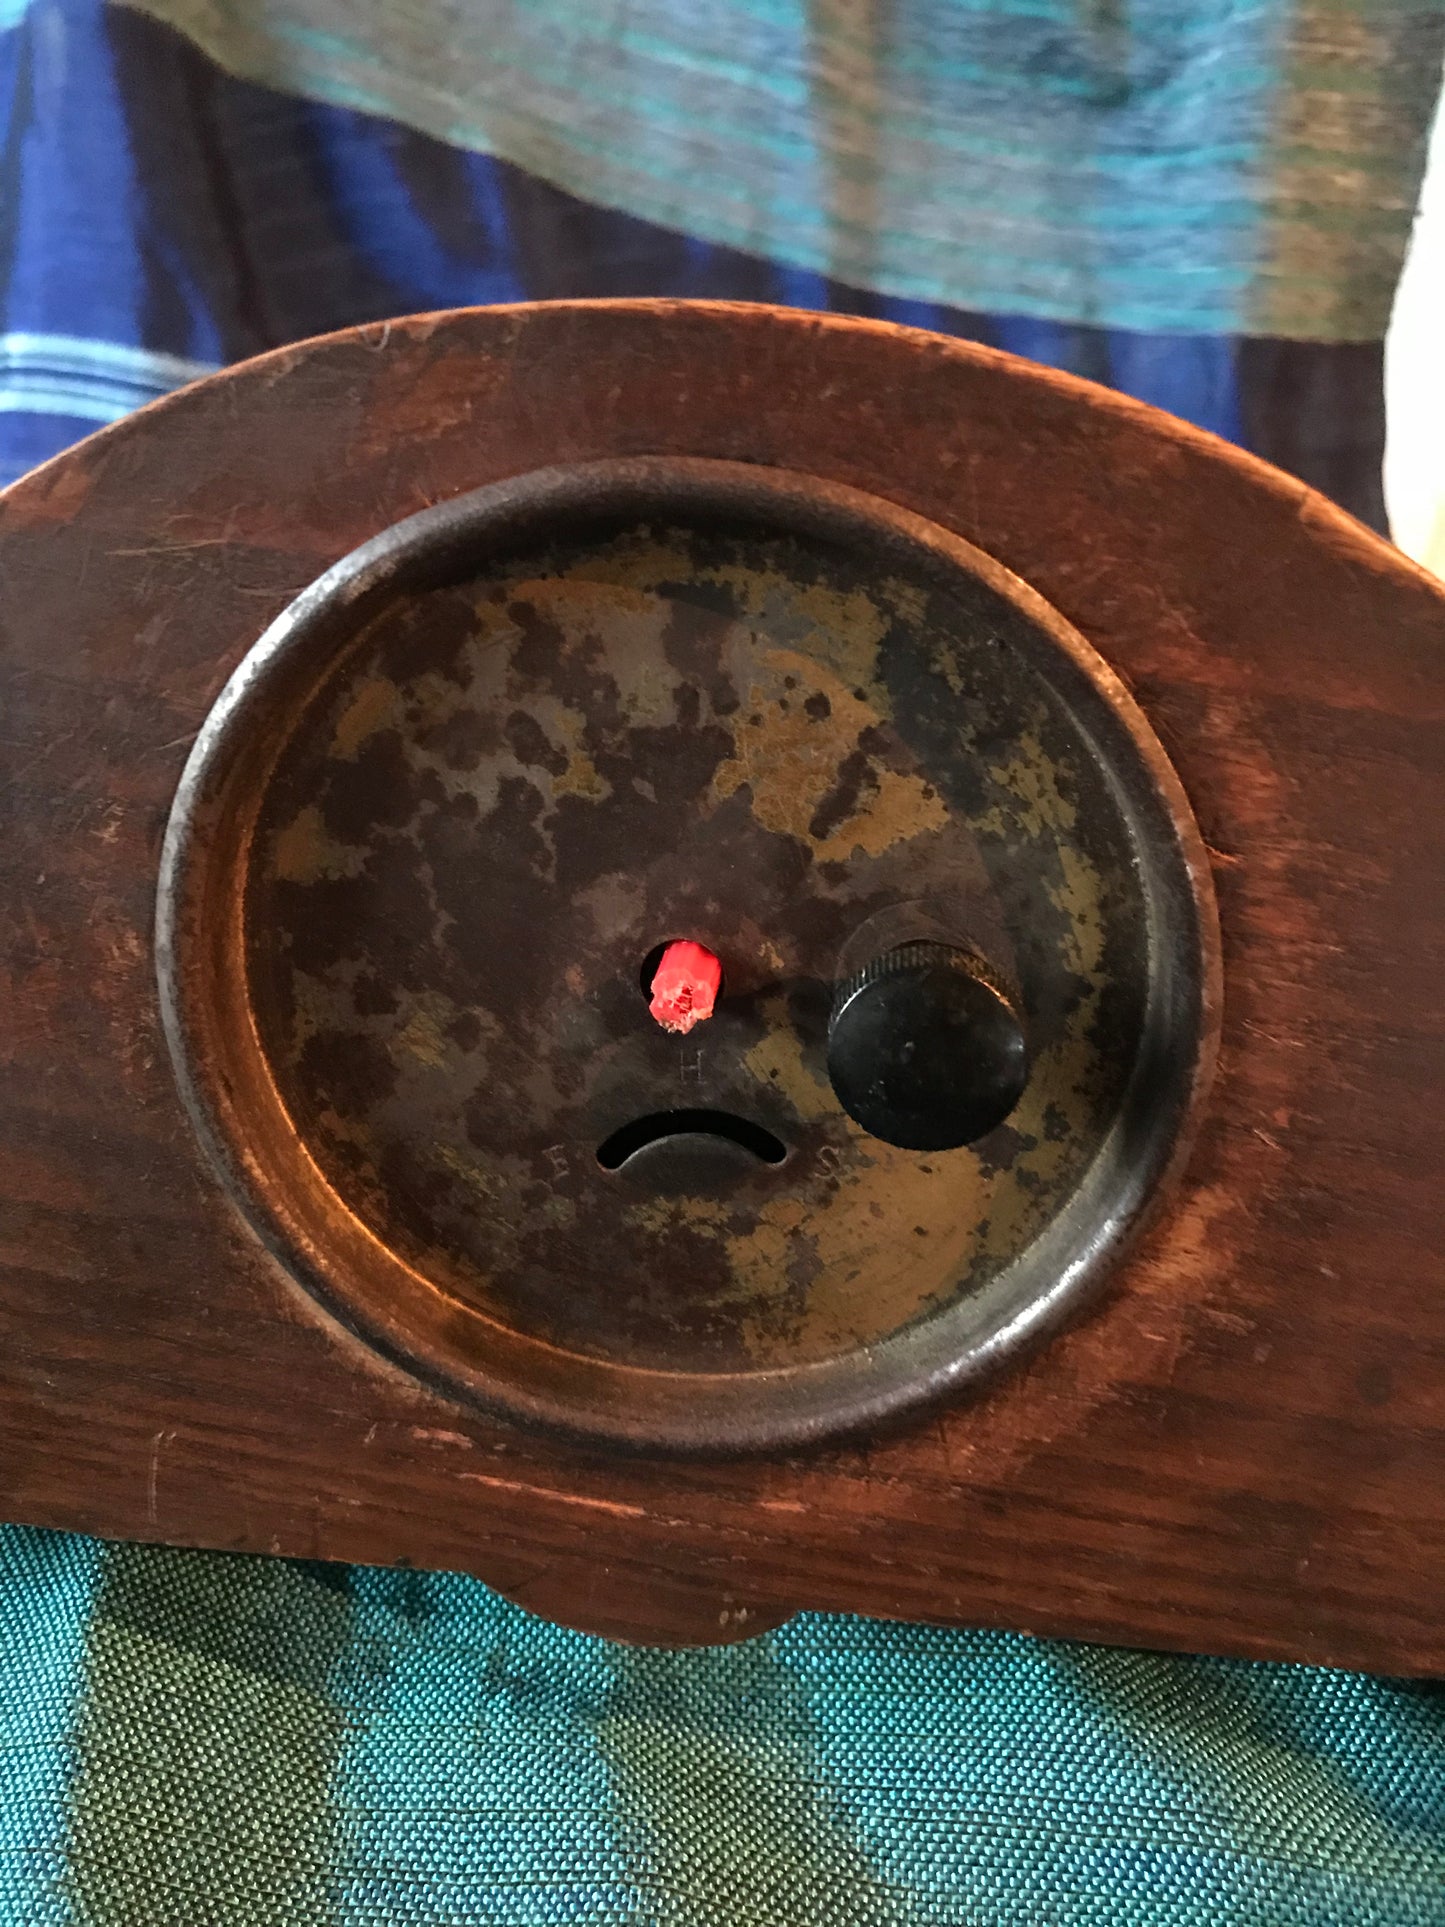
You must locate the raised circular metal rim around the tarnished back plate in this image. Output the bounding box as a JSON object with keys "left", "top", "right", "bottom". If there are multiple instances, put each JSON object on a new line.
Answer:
{"left": 156, "top": 457, "right": 1222, "bottom": 1453}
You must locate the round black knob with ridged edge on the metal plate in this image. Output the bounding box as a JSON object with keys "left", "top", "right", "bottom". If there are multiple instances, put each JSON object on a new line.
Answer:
{"left": 828, "top": 940, "right": 1029, "bottom": 1150}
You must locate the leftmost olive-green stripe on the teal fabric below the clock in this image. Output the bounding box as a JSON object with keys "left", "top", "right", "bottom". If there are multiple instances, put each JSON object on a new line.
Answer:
{"left": 66, "top": 1545, "right": 349, "bottom": 1927}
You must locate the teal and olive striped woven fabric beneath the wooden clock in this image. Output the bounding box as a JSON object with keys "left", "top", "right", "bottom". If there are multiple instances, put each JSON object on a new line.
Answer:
{"left": 0, "top": 1528, "right": 1445, "bottom": 1927}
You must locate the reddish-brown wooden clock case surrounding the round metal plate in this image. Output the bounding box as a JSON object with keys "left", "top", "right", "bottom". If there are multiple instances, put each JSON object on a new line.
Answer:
{"left": 0, "top": 303, "right": 1445, "bottom": 1673}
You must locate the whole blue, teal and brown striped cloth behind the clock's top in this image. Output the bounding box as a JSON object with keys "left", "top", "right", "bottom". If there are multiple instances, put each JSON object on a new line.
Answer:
{"left": 0, "top": 0, "right": 1445, "bottom": 530}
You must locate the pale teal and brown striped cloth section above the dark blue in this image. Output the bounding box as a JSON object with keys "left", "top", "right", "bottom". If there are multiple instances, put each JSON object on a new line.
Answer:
{"left": 113, "top": 0, "right": 1445, "bottom": 341}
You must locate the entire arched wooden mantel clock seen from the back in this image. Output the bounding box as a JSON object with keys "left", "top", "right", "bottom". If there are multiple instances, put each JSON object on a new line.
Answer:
{"left": 0, "top": 303, "right": 1445, "bottom": 1671}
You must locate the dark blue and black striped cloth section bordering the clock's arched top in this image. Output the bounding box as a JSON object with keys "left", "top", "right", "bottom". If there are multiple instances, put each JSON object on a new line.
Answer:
{"left": 0, "top": 0, "right": 1402, "bottom": 530}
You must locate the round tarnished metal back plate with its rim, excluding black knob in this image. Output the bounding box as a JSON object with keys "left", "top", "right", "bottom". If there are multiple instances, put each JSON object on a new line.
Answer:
{"left": 158, "top": 459, "right": 1218, "bottom": 1449}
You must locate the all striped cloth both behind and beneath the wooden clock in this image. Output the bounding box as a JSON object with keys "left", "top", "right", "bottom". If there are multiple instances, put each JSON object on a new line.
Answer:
{"left": 0, "top": 0, "right": 1445, "bottom": 1927}
